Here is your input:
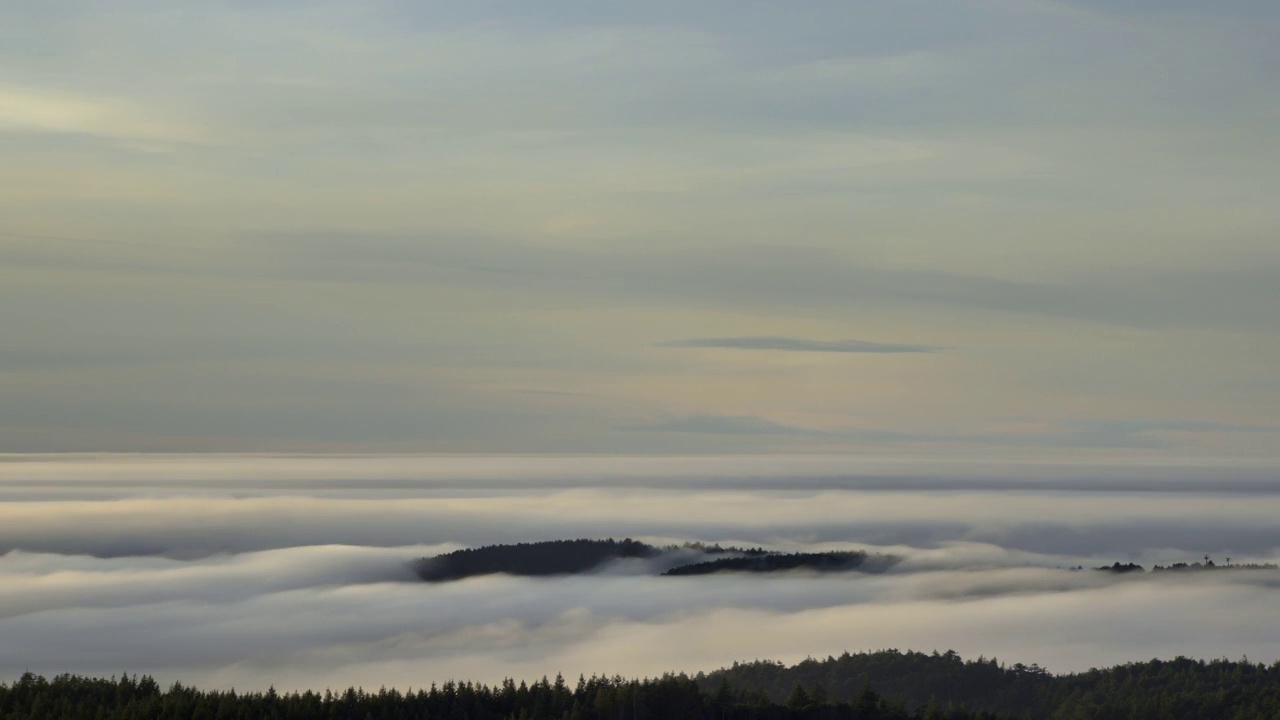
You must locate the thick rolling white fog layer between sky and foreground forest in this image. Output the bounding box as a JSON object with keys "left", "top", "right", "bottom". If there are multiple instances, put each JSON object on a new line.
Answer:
{"left": 0, "top": 455, "right": 1280, "bottom": 689}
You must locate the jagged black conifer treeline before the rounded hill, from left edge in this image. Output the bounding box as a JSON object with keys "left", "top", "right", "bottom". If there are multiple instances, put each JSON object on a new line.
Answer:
{"left": 0, "top": 673, "right": 1000, "bottom": 720}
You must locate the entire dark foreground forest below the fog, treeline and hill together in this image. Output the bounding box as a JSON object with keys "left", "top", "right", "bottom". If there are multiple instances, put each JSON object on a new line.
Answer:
{"left": 10, "top": 651, "right": 1280, "bottom": 720}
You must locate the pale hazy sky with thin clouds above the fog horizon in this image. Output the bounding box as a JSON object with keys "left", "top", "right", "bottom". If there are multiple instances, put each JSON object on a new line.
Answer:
{"left": 0, "top": 0, "right": 1280, "bottom": 450}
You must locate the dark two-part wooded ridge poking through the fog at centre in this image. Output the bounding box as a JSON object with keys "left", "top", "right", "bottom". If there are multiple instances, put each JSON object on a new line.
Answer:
{"left": 415, "top": 538, "right": 897, "bottom": 583}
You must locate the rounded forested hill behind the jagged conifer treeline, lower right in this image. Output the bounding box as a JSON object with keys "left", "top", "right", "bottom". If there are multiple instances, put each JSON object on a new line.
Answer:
{"left": 696, "top": 651, "right": 1280, "bottom": 720}
